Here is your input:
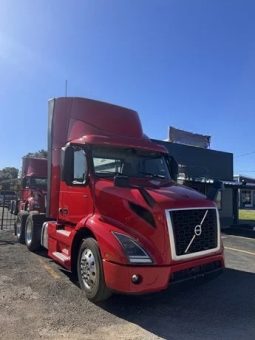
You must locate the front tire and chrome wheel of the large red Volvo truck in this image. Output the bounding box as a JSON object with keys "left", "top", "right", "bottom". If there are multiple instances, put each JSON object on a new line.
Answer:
{"left": 77, "top": 238, "right": 111, "bottom": 302}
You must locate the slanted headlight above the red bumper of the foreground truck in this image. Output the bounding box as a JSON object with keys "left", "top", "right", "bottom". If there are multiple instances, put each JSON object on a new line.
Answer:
{"left": 113, "top": 232, "right": 152, "bottom": 264}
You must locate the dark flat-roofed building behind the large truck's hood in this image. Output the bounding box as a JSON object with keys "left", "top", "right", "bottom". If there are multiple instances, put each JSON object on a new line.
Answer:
{"left": 154, "top": 140, "right": 235, "bottom": 226}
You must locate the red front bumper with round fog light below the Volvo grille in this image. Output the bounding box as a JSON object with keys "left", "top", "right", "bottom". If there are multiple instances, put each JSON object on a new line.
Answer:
{"left": 103, "top": 254, "right": 224, "bottom": 294}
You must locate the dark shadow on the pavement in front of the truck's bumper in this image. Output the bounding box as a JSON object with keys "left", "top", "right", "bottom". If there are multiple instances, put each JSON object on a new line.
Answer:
{"left": 100, "top": 269, "right": 255, "bottom": 339}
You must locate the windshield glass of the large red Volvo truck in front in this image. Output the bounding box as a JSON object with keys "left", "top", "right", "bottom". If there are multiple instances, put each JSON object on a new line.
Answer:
{"left": 92, "top": 146, "right": 170, "bottom": 179}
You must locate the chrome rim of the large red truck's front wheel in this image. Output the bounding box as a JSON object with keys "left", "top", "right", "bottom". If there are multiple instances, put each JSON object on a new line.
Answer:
{"left": 80, "top": 248, "right": 97, "bottom": 290}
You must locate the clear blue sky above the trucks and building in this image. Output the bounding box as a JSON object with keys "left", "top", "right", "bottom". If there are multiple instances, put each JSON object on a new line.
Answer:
{"left": 0, "top": 0, "right": 255, "bottom": 177}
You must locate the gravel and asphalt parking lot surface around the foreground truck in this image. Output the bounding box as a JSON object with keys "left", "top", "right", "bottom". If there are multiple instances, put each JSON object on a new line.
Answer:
{"left": 0, "top": 230, "right": 255, "bottom": 340}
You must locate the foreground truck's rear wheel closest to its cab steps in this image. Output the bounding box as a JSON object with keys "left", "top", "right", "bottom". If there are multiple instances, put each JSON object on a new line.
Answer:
{"left": 25, "top": 213, "right": 45, "bottom": 252}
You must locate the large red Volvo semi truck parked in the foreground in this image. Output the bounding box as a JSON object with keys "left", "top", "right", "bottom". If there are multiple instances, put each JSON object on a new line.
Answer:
{"left": 15, "top": 97, "right": 224, "bottom": 301}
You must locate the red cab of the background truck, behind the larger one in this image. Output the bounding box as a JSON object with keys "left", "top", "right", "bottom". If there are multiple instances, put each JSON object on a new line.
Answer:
{"left": 19, "top": 157, "right": 47, "bottom": 213}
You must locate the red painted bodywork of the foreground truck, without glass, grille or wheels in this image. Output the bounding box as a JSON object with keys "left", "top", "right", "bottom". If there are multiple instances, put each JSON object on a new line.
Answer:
{"left": 47, "top": 98, "right": 224, "bottom": 293}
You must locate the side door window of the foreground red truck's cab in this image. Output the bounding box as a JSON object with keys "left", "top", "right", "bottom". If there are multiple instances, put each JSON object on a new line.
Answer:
{"left": 72, "top": 148, "right": 88, "bottom": 184}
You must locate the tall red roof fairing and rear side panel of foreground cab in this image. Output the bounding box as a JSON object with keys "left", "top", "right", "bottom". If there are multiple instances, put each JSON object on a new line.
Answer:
{"left": 47, "top": 97, "right": 159, "bottom": 219}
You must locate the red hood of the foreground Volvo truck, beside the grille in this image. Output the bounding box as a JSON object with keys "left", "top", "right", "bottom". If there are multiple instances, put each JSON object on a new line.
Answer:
{"left": 95, "top": 179, "right": 214, "bottom": 264}
